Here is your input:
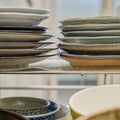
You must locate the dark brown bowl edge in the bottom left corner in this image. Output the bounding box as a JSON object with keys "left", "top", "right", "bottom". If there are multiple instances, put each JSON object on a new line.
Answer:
{"left": 0, "top": 109, "right": 27, "bottom": 120}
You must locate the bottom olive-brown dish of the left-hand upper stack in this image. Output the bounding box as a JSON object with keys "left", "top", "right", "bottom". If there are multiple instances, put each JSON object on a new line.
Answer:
{"left": 0, "top": 53, "right": 56, "bottom": 71}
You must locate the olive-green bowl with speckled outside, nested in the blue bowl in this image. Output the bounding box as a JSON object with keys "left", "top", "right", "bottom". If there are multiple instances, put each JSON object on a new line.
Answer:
{"left": 0, "top": 97, "right": 50, "bottom": 115}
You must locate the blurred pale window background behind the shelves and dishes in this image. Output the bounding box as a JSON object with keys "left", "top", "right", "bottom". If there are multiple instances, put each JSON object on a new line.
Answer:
{"left": 0, "top": 0, "right": 120, "bottom": 104}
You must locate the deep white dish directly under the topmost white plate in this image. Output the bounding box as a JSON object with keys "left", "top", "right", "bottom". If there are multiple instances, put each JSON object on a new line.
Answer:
{"left": 0, "top": 12, "right": 49, "bottom": 26}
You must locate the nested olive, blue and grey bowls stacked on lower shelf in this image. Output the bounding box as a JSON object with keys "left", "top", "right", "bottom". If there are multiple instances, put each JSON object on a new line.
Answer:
{"left": 0, "top": 97, "right": 70, "bottom": 120}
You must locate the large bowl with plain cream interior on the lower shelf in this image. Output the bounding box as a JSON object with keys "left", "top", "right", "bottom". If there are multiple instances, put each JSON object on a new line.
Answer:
{"left": 69, "top": 85, "right": 120, "bottom": 119}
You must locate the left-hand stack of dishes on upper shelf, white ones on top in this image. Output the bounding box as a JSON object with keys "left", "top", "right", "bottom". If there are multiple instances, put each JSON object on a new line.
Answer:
{"left": 0, "top": 7, "right": 55, "bottom": 71}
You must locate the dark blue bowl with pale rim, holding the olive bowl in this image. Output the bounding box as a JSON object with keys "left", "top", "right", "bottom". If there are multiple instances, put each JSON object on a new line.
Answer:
{"left": 25, "top": 101, "right": 60, "bottom": 120}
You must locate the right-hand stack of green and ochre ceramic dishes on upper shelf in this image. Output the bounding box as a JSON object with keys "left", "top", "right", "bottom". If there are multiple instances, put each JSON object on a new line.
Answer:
{"left": 58, "top": 17, "right": 120, "bottom": 70}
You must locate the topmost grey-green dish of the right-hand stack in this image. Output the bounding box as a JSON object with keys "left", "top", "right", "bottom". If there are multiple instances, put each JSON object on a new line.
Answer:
{"left": 60, "top": 16, "right": 120, "bottom": 25}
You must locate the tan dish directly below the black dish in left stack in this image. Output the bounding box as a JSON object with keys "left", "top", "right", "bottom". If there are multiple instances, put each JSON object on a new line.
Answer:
{"left": 0, "top": 33, "right": 53, "bottom": 42}
